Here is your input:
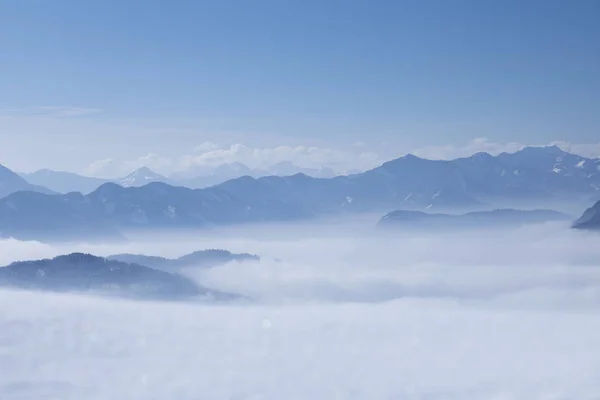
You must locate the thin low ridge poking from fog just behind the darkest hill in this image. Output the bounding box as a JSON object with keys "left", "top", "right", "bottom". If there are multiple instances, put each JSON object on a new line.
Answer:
{"left": 107, "top": 249, "right": 260, "bottom": 270}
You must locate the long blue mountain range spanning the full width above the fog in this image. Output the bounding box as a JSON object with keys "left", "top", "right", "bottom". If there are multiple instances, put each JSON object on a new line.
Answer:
{"left": 0, "top": 146, "right": 600, "bottom": 240}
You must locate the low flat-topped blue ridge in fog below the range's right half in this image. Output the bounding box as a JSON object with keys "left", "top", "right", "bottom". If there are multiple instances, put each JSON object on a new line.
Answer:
{"left": 378, "top": 209, "right": 571, "bottom": 230}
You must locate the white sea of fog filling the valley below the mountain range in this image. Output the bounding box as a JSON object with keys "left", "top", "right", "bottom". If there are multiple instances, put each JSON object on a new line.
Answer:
{"left": 0, "top": 222, "right": 600, "bottom": 400}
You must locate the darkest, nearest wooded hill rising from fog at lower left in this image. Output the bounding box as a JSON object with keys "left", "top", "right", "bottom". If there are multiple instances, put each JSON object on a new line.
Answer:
{"left": 0, "top": 253, "right": 232, "bottom": 300}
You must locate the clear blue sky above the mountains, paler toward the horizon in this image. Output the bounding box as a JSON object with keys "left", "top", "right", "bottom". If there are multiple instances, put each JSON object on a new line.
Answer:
{"left": 0, "top": 0, "right": 600, "bottom": 173}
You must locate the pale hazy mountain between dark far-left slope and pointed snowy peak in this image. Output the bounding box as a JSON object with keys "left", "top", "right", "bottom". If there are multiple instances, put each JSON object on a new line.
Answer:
{"left": 21, "top": 169, "right": 109, "bottom": 193}
